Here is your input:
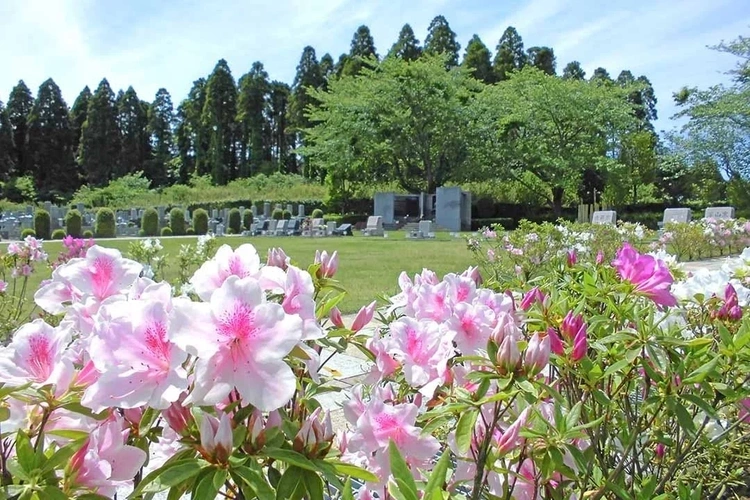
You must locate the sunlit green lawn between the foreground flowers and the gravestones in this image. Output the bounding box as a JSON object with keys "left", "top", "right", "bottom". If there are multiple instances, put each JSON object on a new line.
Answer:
{"left": 11, "top": 232, "right": 472, "bottom": 313}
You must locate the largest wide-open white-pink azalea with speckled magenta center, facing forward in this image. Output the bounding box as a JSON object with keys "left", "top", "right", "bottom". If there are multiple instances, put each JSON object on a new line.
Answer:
{"left": 170, "top": 276, "right": 302, "bottom": 411}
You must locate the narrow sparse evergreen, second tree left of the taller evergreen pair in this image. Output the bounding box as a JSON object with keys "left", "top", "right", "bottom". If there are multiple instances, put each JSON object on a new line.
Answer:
{"left": 144, "top": 88, "right": 175, "bottom": 186}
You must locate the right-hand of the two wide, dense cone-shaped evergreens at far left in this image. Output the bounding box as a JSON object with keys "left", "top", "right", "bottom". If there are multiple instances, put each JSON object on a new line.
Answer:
{"left": 78, "top": 78, "right": 120, "bottom": 186}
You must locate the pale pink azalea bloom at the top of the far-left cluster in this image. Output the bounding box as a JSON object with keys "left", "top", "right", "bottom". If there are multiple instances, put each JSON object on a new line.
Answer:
{"left": 57, "top": 245, "right": 143, "bottom": 302}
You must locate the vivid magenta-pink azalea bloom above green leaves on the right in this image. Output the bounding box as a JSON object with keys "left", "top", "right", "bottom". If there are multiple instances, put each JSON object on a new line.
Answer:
{"left": 612, "top": 243, "right": 677, "bottom": 306}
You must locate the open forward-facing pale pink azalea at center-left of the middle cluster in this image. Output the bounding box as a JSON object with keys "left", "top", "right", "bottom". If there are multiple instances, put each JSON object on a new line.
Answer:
{"left": 390, "top": 318, "right": 455, "bottom": 397}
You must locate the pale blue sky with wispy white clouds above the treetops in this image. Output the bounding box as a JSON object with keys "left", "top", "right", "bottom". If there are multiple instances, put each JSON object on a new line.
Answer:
{"left": 0, "top": 0, "right": 750, "bottom": 129}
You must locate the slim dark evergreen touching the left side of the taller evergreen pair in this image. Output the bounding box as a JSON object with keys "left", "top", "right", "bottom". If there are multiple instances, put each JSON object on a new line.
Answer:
{"left": 175, "top": 78, "right": 209, "bottom": 183}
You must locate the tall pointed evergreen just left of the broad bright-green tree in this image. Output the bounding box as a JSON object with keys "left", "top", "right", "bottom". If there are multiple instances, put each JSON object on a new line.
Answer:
{"left": 288, "top": 46, "right": 323, "bottom": 176}
